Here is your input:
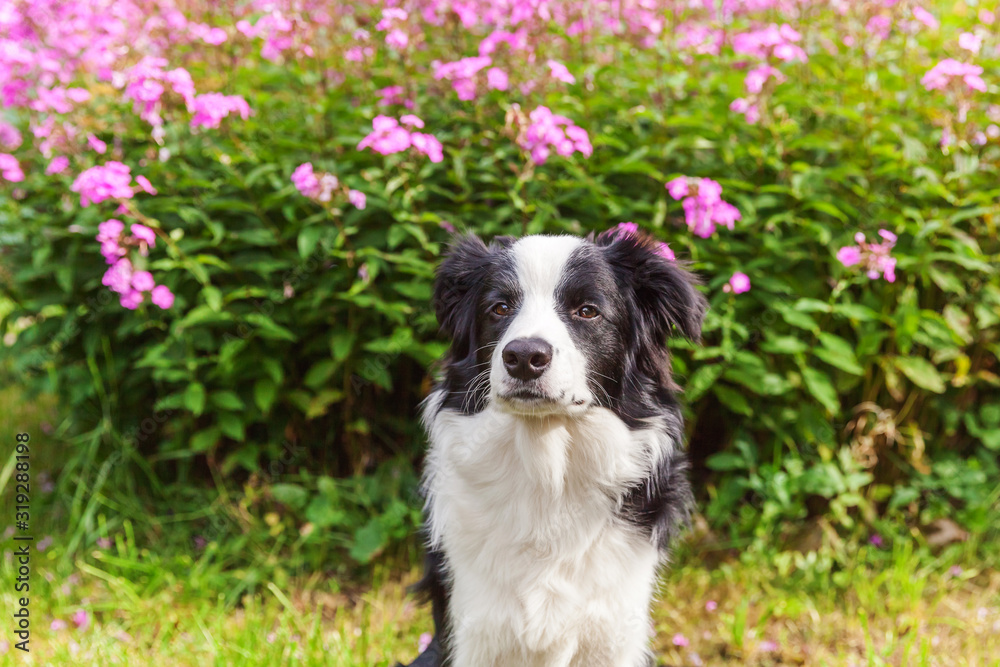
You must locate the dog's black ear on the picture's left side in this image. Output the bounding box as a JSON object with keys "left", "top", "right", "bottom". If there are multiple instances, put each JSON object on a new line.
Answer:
{"left": 434, "top": 234, "right": 493, "bottom": 355}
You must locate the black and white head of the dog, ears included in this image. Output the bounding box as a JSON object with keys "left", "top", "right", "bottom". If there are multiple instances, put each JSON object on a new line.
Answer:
{"left": 434, "top": 230, "right": 707, "bottom": 419}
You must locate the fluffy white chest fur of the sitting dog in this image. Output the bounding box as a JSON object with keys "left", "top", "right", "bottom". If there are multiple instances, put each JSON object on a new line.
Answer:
{"left": 426, "top": 396, "right": 672, "bottom": 667}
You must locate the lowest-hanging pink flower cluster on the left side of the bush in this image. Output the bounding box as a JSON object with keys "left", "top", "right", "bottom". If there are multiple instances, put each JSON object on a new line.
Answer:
{"left": 97, "top": 218, "right": 174, "bottom": 310}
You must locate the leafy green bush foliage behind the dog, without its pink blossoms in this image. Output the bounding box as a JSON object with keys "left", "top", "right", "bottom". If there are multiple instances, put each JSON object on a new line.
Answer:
{"left": 0, "top": 0, "right": 1000, "bottom": 561}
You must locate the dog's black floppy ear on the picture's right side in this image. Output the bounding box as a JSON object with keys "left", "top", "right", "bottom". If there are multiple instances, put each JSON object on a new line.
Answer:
{"left": 595, "top": 230, "right": 708, "bottom": 341}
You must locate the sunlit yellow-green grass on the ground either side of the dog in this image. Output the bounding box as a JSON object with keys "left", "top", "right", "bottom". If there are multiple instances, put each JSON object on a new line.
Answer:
{"left": 0, "top": 544, "right": 1000, "bottom": 667}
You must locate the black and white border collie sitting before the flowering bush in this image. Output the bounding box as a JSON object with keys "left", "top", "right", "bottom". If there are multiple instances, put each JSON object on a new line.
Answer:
{"left": 402, "top": 230, "right": 707, "bottom": 667}
